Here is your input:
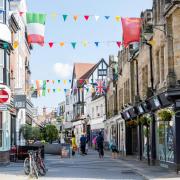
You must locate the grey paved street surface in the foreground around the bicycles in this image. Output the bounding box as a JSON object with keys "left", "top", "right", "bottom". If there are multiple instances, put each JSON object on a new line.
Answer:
{"left": 0, "top": 151, "right": 180, "bottom": 180}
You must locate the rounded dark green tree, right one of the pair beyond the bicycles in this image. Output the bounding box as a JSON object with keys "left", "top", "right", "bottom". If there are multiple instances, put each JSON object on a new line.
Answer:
{"left": 44, "top": 124, "right": 58, "bottom": 143}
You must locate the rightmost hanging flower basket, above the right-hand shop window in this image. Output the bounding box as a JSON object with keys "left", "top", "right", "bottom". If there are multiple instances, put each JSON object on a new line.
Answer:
{"left": 157, "top": 108, "right": 174, "bottom": 121}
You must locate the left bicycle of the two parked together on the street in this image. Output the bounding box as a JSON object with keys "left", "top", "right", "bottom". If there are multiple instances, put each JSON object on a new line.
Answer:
{"left": 24, "top": 150, "right": 39, "bottom": 179}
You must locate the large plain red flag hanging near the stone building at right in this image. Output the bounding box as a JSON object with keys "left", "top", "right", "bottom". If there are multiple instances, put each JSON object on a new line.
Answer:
{"left": 121, "top": 18, "right": 141, "bottom": 47}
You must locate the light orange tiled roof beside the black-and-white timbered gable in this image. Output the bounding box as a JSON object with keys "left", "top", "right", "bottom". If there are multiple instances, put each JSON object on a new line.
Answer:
{"left": 74, "top": 63, "right": 95, "bottom": 79}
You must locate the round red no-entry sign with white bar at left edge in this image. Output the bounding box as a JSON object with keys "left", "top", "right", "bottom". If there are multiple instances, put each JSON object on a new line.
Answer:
{"left": 0, "top": 84, "right": 11, "bottom": 104}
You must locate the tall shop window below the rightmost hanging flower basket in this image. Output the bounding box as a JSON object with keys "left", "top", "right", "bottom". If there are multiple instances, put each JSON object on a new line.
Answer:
{"left": 158, "top": 121, "right": 174, "bottom": 162}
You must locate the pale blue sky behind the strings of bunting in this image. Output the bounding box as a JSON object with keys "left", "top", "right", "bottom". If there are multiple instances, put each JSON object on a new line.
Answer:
{"left": 27, "top": 0, "right": 152, "bottom": 110}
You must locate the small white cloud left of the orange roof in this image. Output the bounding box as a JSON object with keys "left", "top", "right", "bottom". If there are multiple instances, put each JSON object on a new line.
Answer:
{"left": 53, "top": 63, "right": 73, "bottom": 78}
